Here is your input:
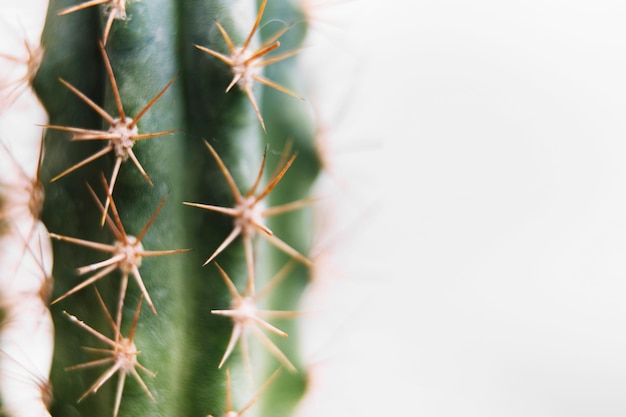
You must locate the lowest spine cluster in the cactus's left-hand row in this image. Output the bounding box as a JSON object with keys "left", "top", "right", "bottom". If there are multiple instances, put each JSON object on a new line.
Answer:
{"left": 63, "top": 289, "right": 156, "bottom": 417}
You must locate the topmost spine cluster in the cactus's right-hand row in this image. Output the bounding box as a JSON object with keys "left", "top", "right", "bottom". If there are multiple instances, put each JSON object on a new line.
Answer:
{"left": 194, "top": 0, "right": 301, "bottom": 132}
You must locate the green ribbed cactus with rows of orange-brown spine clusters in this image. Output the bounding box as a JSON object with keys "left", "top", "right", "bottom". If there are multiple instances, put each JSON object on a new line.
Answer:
{"left": 0, "top": 0, "right": 320, "bottom": 417}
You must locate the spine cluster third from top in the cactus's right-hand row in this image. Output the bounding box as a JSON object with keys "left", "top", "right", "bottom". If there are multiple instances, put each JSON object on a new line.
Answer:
{"left": 211, "top": 263, "right": 298, "bottom": 374}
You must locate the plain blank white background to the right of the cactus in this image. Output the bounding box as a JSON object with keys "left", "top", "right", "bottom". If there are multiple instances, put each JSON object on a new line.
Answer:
{"left": 302, "top": 0, "right": 626, "bottom": 417}
